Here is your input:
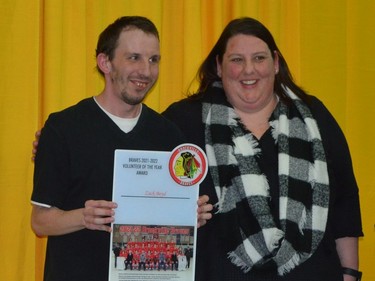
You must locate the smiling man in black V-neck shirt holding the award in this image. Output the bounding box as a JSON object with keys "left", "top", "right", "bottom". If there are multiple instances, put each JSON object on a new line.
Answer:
{"left": 31, "top": 17, "right": 213, "bottom": 281}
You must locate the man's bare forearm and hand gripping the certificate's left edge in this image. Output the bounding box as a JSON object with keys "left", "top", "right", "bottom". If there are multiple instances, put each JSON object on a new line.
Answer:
{"left": 31, "top": 200, "right": 117, "bottom": 236}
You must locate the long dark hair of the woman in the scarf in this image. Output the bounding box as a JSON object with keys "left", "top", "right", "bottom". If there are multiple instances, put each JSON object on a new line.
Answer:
{"left": 197, "top": 17, "right": 307, "bottom": 103}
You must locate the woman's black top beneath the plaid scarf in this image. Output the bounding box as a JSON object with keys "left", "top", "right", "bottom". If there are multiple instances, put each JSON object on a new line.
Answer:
{"left": 163, "top": 90, "right": 363, "bottom": 281}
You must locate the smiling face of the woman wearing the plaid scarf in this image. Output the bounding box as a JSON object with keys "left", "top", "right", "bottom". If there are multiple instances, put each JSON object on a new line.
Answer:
{"left": 217, "top": 34, "right": 279, "bottom": 113}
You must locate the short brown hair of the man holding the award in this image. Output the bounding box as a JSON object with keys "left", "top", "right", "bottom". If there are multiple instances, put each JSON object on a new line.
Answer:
{"left": 96, "top": 16, "right": 160, "bottom": 74}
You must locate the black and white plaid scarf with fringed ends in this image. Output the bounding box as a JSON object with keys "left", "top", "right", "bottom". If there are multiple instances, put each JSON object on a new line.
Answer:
{"left": 202, "top": 84, "right": 329, "bottom": 275}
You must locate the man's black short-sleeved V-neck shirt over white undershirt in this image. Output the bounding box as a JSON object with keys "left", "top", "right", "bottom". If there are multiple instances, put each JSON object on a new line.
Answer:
{"left": 31, "top": 98, "right": 184, "bottom": 281}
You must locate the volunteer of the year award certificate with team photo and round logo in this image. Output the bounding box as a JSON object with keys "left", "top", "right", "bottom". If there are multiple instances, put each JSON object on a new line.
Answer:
{"left": 109, "top": 144, "right": 207, "bottom": 281}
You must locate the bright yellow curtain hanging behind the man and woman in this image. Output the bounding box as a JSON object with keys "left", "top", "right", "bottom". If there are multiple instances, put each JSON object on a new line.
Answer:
{"left": 0, "top": 0, "right": 375, "bottom": 281}
